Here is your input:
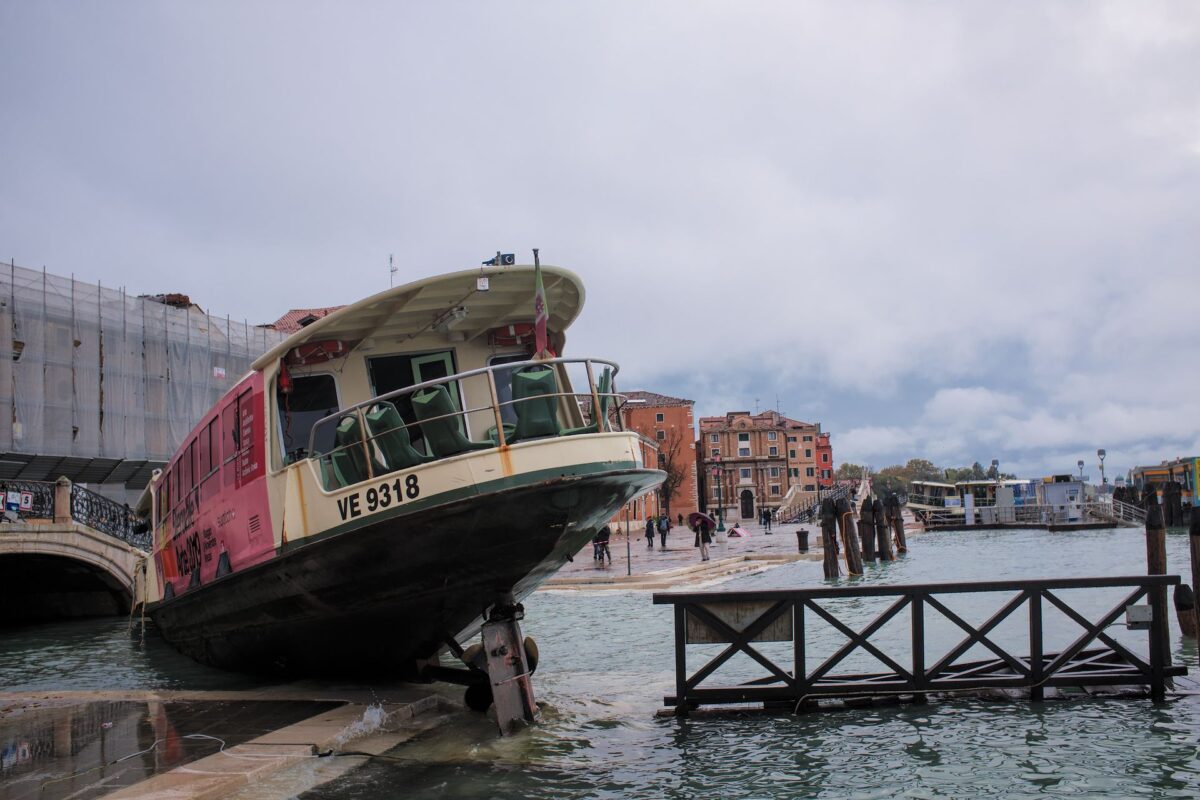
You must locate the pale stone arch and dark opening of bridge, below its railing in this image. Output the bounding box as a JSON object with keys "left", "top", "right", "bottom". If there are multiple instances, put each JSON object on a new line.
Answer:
{"left": 0, "top": 523, "right": 145, "bottom": 626}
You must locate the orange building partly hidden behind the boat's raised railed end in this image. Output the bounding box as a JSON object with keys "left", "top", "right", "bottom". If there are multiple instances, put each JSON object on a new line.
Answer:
{"left": 620, "top": 391, "right": 700, "bottom": 524}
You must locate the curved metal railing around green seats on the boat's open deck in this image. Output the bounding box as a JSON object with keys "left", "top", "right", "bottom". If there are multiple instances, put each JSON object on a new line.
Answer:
{"left": 306, "top": 357, "right": 624, "bottom": 491}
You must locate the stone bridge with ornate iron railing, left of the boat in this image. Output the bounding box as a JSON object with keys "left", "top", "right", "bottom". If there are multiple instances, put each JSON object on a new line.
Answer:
{"left": 0, "top": 481, "right": 146, "bottom": 626}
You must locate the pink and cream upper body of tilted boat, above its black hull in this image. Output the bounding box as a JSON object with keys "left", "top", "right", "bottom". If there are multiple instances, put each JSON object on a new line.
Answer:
{"left": 143, "top": 266, "right": 642, "bottom": 599}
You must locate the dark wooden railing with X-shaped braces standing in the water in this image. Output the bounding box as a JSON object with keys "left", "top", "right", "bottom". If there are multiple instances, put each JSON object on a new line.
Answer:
{"left": 654, "top": 575, "right": 1187, "bottom": 714}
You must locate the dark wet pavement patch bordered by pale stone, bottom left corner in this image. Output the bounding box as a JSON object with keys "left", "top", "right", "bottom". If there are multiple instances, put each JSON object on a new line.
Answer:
{"left": 0, "top": 700, "right": 340, "bottom": 800}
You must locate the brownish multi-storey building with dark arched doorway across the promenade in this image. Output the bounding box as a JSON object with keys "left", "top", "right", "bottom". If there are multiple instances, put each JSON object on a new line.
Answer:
{"left": 696, "top": 410, "right": 833, "bottom": 519}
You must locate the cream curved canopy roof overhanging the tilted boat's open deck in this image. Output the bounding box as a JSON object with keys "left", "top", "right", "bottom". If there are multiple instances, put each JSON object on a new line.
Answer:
{"left": 252, "top": 264, "right": 584, "bottom": 369}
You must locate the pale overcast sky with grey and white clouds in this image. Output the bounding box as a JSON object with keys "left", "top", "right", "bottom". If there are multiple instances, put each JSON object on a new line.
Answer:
{"left": 0, "top": 0, "right": 1200, "bottom": 476}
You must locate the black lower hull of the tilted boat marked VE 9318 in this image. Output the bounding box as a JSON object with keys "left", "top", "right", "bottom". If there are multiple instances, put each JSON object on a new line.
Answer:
{"left": 150, "top": 469, "right": 661, "bottom": 676}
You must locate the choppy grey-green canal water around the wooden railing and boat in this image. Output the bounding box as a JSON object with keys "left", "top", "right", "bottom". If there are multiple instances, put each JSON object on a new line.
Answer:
{"left": 0, "top": 530, "right": 1200, "bottom": 800}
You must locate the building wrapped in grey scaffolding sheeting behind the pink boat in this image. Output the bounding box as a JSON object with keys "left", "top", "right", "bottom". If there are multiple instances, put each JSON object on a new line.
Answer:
{"left": 0, "top": 264, "right": 286, "bottom": 499}
